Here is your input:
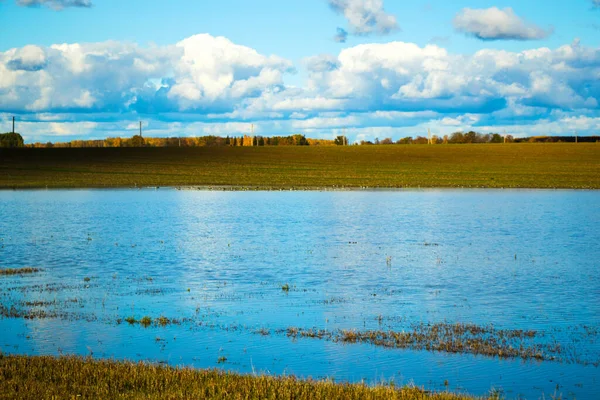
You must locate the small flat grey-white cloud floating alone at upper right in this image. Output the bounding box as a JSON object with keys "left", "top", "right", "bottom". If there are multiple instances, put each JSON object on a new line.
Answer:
{"left": 454, "top": 7, "right": 551, "bottom": 40}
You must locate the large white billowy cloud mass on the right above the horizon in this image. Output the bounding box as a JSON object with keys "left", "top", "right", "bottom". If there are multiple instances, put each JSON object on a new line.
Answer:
{"left": 308, "top": 42, "right": 600, "bottom": 112}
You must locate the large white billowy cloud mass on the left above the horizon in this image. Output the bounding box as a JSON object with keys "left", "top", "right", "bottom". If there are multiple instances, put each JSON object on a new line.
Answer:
{"left": 0, "top": 34, "right": 292, "bottom": 113}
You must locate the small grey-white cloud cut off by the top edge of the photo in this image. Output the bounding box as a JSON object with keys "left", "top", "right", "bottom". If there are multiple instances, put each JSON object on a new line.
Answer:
{"left": 327, "top": 0, "right": 399, "bottom": 38}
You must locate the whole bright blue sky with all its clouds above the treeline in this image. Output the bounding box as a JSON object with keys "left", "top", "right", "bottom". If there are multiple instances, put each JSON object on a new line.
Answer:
{"left": 0, "top": 0, "right": 600, "bottom": 142}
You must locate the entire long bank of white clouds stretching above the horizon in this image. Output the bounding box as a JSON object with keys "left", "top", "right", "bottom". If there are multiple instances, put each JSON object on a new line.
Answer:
{"left": 0, "top": 34, "right": 600, "bottom": 139}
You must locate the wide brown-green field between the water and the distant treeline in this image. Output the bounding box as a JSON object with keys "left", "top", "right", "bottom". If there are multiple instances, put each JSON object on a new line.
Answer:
{"left": 0, "top": 143, "right": 600, "bottom": 189}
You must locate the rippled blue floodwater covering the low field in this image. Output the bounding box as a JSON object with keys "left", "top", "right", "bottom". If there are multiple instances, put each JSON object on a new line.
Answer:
{"left": 0, "top": 189, "right": 600, "bottom": 399}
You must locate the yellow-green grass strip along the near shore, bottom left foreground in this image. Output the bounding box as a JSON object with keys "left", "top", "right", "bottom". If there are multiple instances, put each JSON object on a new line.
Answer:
{"left": 0, "top": 354, "right": 495, "bottom": 400}
